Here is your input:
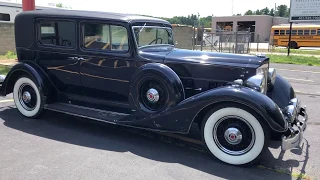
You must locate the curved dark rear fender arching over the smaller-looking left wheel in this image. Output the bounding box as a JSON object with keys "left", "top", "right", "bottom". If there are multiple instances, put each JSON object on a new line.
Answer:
{"left": 2, "top": 61, "right": 56, "bottom": 102}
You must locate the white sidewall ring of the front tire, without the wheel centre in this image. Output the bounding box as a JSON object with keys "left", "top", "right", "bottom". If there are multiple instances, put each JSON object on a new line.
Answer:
{"left": 202, "top": 106, "right": 269, "bottom": 165}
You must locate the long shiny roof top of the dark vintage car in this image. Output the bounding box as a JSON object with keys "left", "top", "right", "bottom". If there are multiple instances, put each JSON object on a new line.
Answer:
{"left": 17, "top": 9, "right": 170, "bottom": 24}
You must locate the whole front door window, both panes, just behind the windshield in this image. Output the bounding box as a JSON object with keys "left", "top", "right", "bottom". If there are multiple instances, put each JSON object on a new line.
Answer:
{"left": 84, "top": 23, "right": 129, "bottom": 51}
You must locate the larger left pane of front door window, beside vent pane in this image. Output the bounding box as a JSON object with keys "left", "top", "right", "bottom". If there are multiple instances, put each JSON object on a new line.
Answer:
{"left": 84, "top": 23, "right": 111, "bottom": 50}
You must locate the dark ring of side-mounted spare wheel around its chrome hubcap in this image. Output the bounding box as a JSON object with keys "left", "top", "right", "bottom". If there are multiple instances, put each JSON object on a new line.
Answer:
{"left": 129, "top": 63, "right": 185, "bottom": 117}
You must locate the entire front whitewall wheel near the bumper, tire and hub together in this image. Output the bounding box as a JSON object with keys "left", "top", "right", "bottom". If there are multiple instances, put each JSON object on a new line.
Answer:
{"left": 202, "top": 106, "right": 269, "bottom": 165}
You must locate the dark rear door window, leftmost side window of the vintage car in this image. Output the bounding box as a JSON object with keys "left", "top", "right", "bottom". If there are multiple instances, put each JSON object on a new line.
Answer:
{"left": 39, "top": 21, "right": 76, "bottom": 48}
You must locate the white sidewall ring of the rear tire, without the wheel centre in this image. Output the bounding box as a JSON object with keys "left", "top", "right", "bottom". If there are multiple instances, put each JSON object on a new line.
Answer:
{"left": 13, "top": 76, "right": 43, "bottom": 118}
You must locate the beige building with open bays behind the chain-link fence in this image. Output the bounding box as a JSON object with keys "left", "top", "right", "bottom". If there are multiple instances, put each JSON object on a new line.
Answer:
{"left": 212, "top": 15, "right": 289, "bottom": 42}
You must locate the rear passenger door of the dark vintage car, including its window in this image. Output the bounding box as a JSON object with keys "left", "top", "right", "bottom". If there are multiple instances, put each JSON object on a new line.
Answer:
{"left": 36, "top": 18, "right": 82, "bottom": 95}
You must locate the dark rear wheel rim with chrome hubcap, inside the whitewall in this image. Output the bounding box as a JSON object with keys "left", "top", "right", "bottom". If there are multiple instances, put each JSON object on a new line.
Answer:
{"left": 18, "top": 83, "right": 37, "bottom": 111}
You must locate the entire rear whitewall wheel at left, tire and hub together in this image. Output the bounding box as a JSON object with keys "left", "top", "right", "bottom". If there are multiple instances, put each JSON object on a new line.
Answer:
{"left": 13, "top": 77, "right": 43, "bottom": 118}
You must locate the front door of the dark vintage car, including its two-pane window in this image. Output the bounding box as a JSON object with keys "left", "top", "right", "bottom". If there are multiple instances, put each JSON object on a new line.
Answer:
{"left": 79, "top": 21, "right": 134, "bottom": 102}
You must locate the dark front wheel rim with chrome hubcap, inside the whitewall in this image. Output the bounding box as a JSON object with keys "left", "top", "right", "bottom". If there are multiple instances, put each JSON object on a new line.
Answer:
{"left": 212, "top": 116, "right": 255, "bottom": 156}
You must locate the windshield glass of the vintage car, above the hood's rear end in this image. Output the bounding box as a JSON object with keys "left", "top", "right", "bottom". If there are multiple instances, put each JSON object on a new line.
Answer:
{"left": 133, "top": 26, "right": 174, "bottom": 47}
